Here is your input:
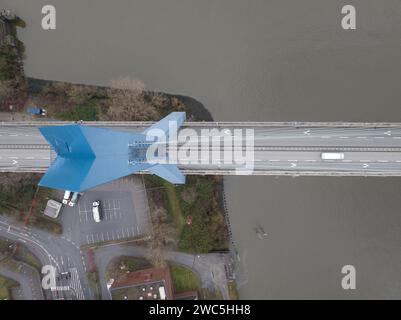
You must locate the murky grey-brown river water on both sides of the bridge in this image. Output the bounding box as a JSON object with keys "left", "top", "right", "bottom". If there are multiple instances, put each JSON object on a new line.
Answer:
{"left": 0, "top": 0, "right": 401, "bottom": 299}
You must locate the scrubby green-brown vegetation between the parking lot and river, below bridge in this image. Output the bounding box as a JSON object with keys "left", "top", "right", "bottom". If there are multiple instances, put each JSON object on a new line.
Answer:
{"left": 145, "top": 176, "right": 228, "bottom": 253}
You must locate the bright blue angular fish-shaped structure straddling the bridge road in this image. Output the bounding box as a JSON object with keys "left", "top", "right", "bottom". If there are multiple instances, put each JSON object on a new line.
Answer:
{"left": 39, "top": 112, "right": 185, "bottom": 192}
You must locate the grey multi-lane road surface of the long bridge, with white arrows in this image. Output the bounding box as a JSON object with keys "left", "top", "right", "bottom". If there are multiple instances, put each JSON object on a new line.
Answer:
{"left": 0, "top": 122, "right": 401, "bottom": 176}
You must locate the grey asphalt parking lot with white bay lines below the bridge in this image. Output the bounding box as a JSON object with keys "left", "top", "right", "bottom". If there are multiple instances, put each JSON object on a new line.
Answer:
{"left": 61, "top": 177, "right": 149, "bottom": 245}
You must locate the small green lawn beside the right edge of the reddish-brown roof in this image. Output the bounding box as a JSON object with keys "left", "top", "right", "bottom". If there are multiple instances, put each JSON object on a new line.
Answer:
{"left": 169, "top": 264, "right": 200, "bottom": 293}
